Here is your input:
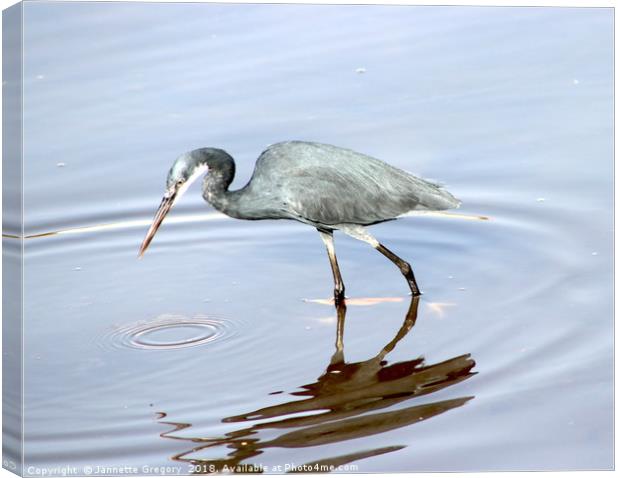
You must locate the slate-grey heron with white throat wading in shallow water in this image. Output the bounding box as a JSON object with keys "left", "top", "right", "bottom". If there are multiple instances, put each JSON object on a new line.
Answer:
{"left": 139, "top": 141, "right": 460, "bottom": 304}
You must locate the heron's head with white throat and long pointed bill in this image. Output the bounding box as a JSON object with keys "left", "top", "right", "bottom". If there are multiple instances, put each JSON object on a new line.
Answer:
{"left": 138, "top": 148, "right": 210, "bottom": 257}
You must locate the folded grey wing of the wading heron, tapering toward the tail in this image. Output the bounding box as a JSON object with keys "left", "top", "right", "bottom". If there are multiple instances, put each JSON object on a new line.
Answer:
{"left": 265, "top": 143, "right": 459, "bottom": 225}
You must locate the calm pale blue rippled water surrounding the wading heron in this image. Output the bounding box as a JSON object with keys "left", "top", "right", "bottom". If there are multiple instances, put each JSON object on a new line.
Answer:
{"left": 14, "top": 3, "right": 613, "bottom": 474}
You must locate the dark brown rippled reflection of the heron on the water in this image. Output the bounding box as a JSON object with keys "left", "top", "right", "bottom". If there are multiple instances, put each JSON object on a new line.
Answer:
{"left": 159, "top": 297, "right": 475, "bottom": 473}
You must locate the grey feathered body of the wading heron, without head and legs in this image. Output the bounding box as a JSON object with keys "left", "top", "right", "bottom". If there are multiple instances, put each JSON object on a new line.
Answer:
{"left": 203, "top": 141, "right": 459, "bottom": 229}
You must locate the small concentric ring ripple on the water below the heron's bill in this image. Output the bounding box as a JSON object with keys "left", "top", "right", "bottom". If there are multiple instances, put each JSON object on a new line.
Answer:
{"left": 101, "top": 314, "right": 235, "bottom": 350}
